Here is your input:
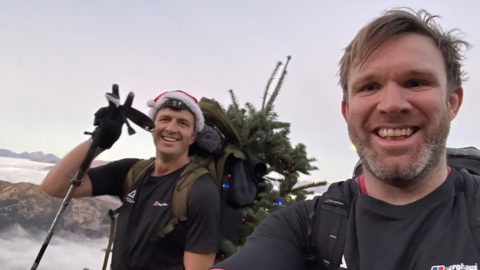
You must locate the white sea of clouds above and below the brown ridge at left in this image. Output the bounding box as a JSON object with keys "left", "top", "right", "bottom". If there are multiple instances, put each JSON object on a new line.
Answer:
{"left": 0, "top": 157, "right": 108, "bottom": 270}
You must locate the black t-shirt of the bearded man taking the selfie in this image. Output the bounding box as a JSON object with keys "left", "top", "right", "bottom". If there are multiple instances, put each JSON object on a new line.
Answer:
{"left": 213, "top": 169, "right": 480, "bottom": 270}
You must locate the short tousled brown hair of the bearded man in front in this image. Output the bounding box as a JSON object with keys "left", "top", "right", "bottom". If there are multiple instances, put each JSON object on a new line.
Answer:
{"left": 338, "top": 8, "right": 470, "bottom": 101}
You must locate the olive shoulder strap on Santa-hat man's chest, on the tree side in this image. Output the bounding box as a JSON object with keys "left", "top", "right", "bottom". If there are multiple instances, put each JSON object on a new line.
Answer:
{"left": 157, "top": 162, "right": 208, "bottom": 238}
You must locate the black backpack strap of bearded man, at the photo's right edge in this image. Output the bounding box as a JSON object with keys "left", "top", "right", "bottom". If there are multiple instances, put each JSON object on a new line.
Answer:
{"left": 460, "top": 169, "right": 480, "bottom": 253}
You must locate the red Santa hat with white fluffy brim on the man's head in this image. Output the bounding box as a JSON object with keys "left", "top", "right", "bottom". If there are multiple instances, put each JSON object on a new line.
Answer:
{"left": 147, "top": 90, "right": 204, "bottom": 132}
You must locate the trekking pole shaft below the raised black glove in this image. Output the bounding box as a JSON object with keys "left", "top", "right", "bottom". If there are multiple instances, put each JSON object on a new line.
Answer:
{"left": 31, "top": 133, "right": 98, "bottom": 270}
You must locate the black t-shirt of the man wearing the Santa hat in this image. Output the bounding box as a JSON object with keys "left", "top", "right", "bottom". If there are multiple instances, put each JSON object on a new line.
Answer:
{"left": 88, "top": 159, "right": 220, "bottom": 270}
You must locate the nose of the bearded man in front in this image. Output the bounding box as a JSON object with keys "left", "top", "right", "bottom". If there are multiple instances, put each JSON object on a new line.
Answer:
{"left": 377, "top": 82, "right": 412, "bottom": 114}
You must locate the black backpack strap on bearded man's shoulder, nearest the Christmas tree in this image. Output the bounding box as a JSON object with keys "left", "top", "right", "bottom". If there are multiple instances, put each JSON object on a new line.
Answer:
{"left": 311, "top": 179, "right": 353, "bottom": 270}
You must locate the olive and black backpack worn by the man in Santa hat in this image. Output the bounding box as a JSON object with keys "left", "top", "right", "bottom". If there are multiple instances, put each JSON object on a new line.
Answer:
{"left": 103, "top": 98, "right": 267, "bottom": 269}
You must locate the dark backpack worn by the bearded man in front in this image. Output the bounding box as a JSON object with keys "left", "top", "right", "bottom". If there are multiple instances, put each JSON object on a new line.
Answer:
{"left": 304, "top": 147, "right": 480, "bottom": 270}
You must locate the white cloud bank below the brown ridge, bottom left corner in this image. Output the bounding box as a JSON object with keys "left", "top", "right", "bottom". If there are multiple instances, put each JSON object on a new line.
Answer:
{"left": 0, "top": 226, "right": 108, "bottom": 270}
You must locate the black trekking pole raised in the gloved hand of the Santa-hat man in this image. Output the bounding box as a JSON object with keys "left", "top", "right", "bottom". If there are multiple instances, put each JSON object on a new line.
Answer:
{"left": 31, "top": 84, "right": 154, "bottom": 270}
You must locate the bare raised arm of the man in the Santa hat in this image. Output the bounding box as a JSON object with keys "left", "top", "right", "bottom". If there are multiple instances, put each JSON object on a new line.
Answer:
{"left": 40, "top": 142, "right": 102, "bottom": 197}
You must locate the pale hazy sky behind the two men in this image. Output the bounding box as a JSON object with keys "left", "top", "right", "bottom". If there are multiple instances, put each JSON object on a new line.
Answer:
{"left": 0, "top": 0, "right": 480, "bottom": 185}
